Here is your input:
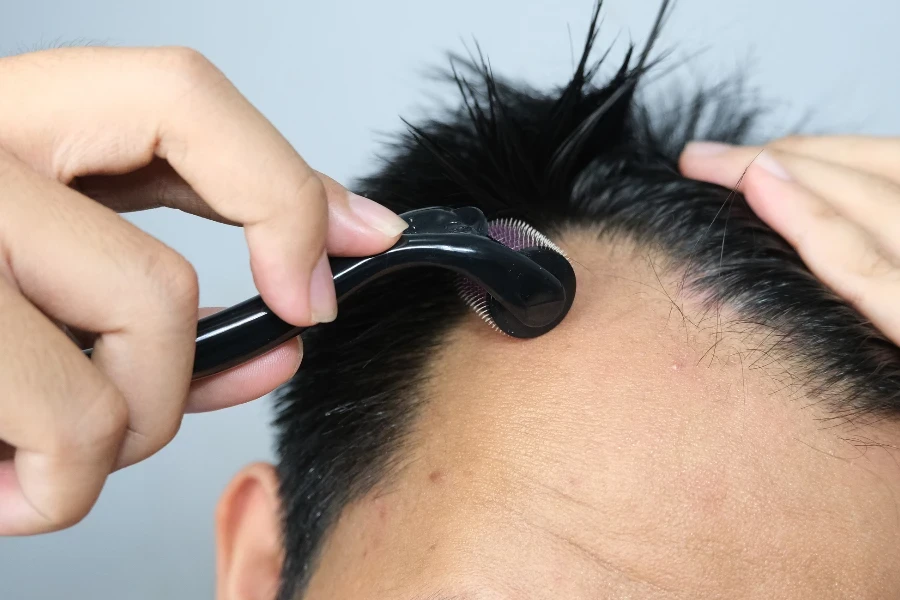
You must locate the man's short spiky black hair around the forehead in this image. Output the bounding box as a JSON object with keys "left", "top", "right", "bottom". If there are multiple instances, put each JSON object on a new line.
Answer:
{"left": 275, "top": 1, "right": 900, "bottom": 600}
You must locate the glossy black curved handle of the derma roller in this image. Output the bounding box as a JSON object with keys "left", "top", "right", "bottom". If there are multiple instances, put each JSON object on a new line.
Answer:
{"left": 84, "top": 209, "right": 571, "bottom": 379}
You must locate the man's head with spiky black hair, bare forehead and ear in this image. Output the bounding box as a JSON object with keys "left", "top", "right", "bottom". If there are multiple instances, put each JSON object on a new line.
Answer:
{"left": 209, "top": 2, "right": 900, "bottom": 600}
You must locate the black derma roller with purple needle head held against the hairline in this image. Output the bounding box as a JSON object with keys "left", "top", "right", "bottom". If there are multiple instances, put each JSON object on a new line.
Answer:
{"left": 84, "top": 207, "right": 575, "bottom": 379}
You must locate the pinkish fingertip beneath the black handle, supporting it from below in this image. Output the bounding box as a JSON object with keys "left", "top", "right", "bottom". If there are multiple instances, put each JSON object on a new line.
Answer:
{"left": 186, "top": 308, "right": 303, "bottom": 412}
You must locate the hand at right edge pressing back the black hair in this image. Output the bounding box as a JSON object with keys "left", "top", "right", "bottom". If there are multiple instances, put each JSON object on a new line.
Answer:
{"left": 681, "top": 136, "right": 900, "bottom": 345}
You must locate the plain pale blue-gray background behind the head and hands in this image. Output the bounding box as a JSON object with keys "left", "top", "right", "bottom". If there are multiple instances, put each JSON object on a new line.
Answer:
{"left": 0, "top": 0, "right": 900, "bottom": 600}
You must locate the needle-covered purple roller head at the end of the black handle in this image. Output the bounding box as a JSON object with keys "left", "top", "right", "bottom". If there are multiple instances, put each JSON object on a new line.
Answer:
{"left": 457, "top": 219, "right": 575, "bottom": 338}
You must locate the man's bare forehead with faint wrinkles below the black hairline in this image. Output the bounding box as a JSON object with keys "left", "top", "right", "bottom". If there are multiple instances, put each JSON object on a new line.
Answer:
{"left": 300, "top": 233, "right": 900, "bottom": 600}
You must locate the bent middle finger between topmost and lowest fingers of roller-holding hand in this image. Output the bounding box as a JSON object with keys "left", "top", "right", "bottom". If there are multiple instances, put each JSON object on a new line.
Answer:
{"left": 0, "top": 153, "right": 198, "bottom": 466}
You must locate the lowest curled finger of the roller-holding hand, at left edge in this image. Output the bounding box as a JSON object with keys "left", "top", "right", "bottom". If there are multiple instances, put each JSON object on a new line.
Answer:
{"left": 0, "top": 278, "right": 128, "bottom": 535}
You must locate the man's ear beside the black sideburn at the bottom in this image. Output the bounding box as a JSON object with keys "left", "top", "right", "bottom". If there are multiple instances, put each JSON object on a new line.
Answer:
{"left": 216, "top": 463, "right": 284, "bottom": 600}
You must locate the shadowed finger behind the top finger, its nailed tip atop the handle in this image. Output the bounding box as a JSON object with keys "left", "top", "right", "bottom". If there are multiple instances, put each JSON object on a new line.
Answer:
{"left": 72, "top": 159, "right": 405, "bottom": 256}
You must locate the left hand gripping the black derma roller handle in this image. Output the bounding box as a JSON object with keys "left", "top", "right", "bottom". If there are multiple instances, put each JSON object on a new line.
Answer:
{"left": 0, "top": 48, "right": 405, "bottom": 535}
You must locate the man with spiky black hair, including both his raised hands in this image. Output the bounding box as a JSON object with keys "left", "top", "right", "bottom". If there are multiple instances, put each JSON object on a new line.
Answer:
{"left": 0, "top": 2, "right": 900, "bottom": 600}
